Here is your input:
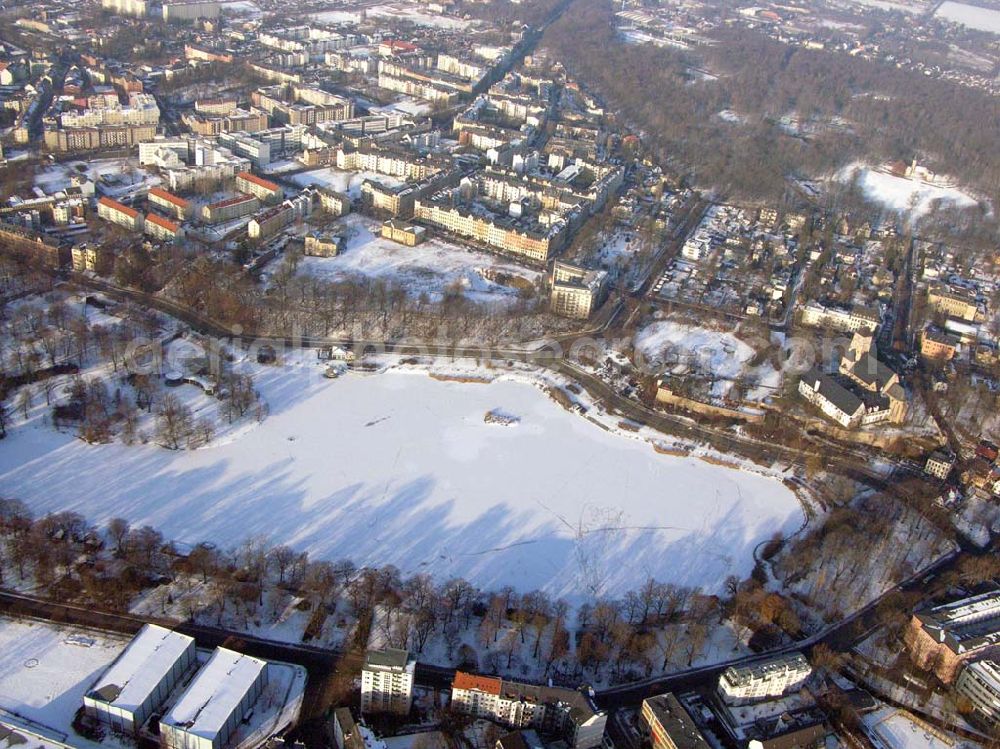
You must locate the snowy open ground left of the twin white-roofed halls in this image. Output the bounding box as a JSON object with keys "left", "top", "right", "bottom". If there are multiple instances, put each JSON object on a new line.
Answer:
{"left": 0, "top": 619, "right": 128, "bottom": 746}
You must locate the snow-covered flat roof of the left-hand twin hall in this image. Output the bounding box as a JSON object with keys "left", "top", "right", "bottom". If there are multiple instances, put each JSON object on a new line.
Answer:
{"left": 87, "top": 624, "right": 194, "bottom": 712}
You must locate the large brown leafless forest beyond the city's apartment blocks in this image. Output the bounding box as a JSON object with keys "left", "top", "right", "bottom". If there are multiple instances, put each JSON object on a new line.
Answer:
{"left": 544, "top": 0, "right": 1000, "bottom": 205}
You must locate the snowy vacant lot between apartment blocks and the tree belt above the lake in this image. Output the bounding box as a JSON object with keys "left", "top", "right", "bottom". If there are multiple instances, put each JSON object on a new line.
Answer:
{"left": 286, "top": 214, "right": 539, "bottom": 302}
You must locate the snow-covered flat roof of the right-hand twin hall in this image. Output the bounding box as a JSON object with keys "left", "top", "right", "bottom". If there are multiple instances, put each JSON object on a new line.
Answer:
{"left": 160, "top": 648, "right": 267, "bottom": 739}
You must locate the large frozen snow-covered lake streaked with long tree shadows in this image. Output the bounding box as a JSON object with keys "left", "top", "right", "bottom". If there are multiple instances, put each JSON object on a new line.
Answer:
{"left": 0, "top": 365, "right": 803, "bottom": 601}
